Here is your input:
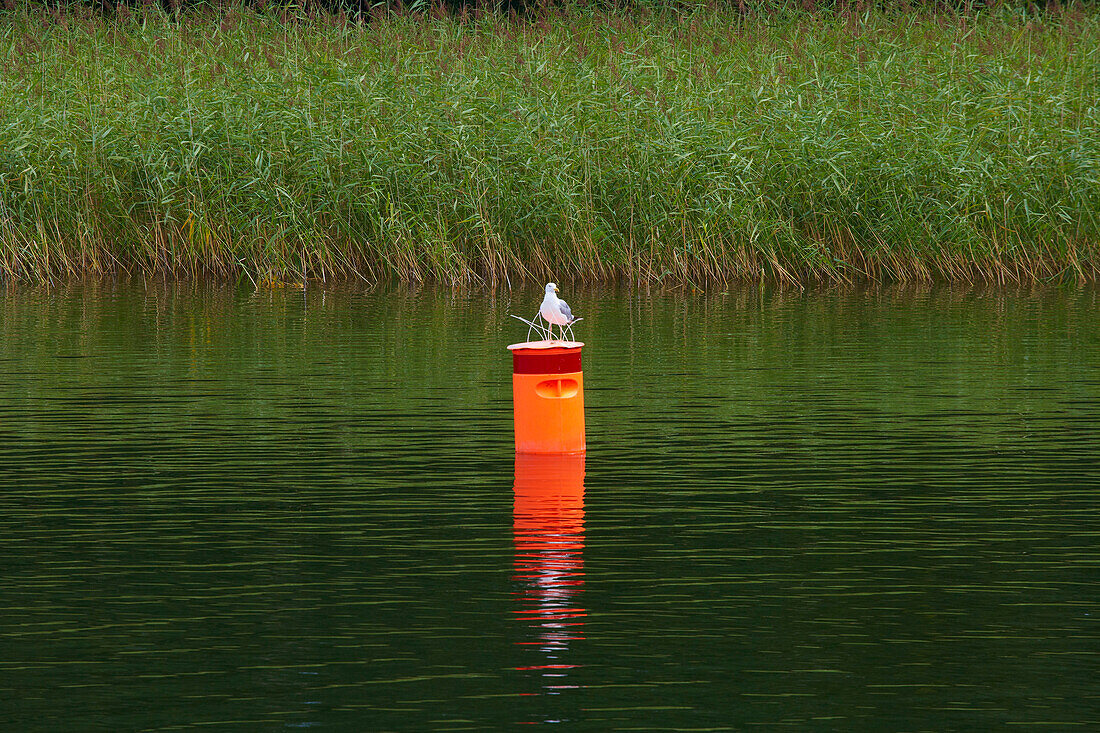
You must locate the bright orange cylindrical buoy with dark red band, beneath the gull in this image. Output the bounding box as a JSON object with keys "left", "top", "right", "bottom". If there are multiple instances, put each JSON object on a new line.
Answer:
{"left": 508, "top": 341, "right": 585, "bottom": 453}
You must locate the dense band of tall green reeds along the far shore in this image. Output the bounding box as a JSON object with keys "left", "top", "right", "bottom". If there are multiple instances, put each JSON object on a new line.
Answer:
{"left": 0, "top": 6, "right": 1100, "bottom": 285}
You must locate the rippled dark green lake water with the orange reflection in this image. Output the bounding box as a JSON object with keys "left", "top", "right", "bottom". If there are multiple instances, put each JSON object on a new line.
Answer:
{"left": 0, "top": 283, "right": 1100, "bottom": 731}
